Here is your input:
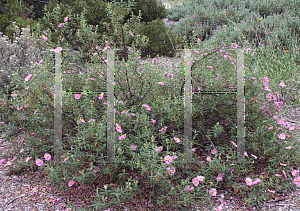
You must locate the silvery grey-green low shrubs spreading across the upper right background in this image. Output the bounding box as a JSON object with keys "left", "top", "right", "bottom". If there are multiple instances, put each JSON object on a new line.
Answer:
{"left": 168, "top": 0, "right": 300, "bottom": 53}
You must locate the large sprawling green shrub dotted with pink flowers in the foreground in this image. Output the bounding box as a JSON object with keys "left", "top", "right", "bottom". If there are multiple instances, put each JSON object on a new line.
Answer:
{"left": 0, "top": 0, "right": 300, "bottom": 210}
